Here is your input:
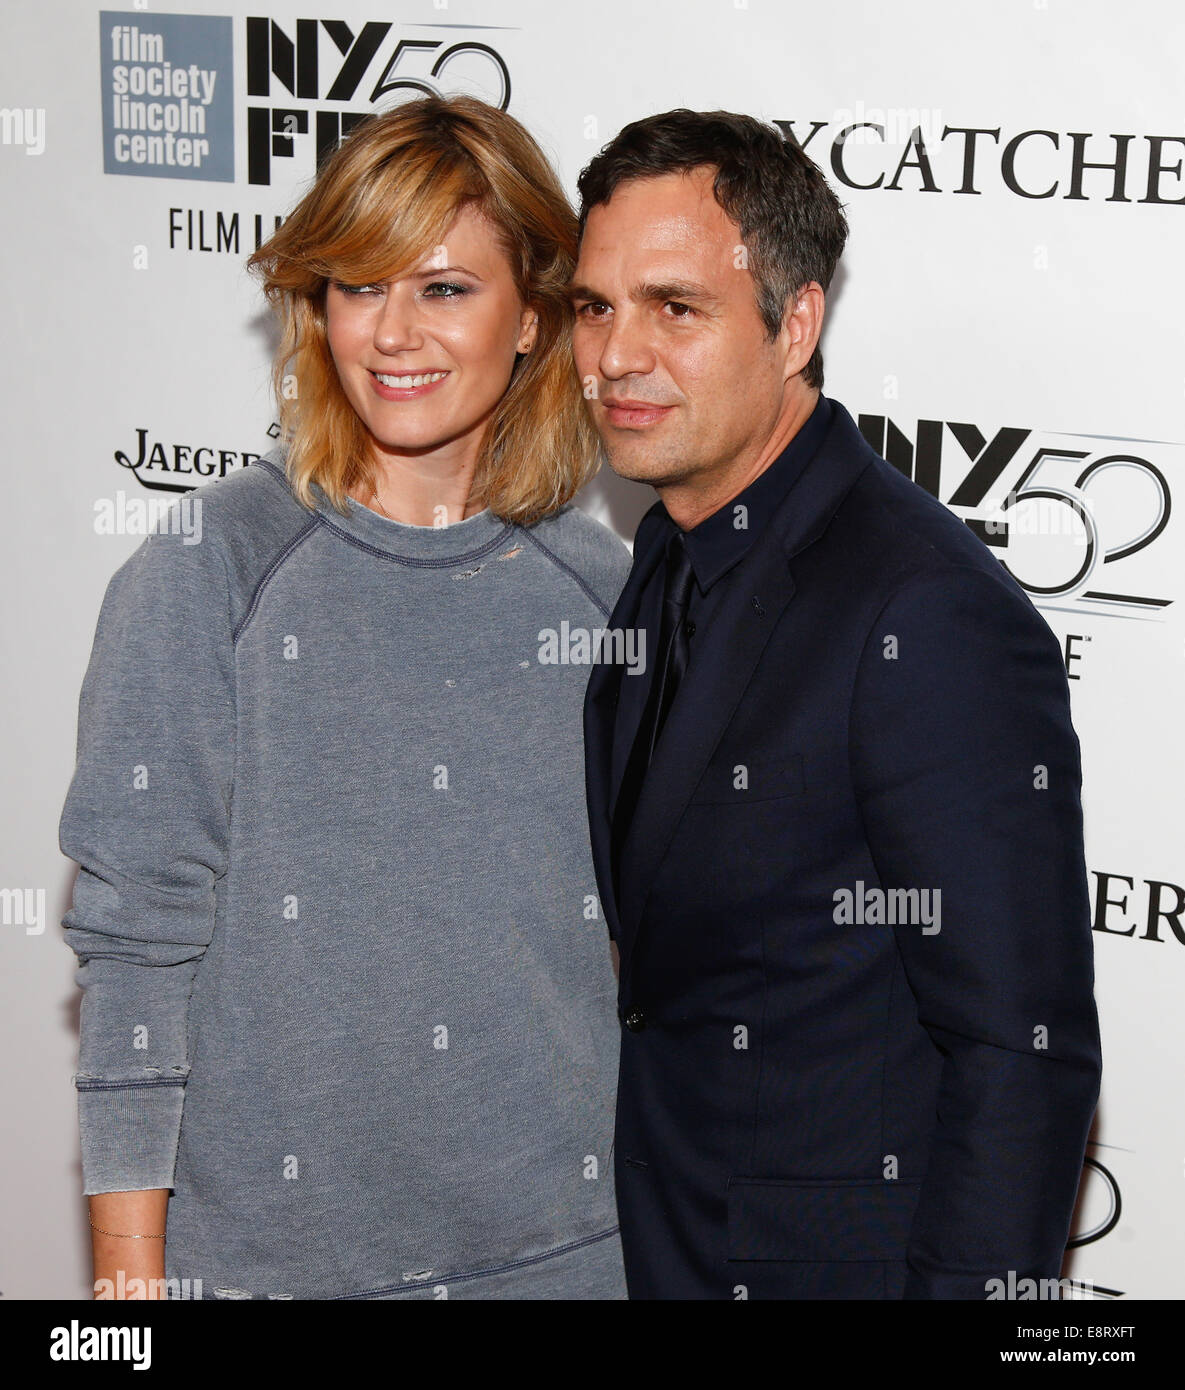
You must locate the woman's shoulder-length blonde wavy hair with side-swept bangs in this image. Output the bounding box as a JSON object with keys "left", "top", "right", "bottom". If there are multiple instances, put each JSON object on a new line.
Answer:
{"left": 247, "top": 96, "right": 600, "bottom": 525}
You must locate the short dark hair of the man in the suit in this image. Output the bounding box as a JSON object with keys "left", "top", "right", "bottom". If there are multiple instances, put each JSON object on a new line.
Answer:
{"left": 577, "top": 107, "right": 847, "bottom": 386}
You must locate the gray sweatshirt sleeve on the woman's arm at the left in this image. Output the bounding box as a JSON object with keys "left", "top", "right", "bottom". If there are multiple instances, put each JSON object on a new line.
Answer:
{"left": 58, "top": 509, "right": 235, "bottom": 1194}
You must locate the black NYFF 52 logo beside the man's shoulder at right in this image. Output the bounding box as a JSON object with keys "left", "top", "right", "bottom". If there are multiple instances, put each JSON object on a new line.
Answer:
{"left": 859, "top": 414, "right": 1185, "bottom": 617}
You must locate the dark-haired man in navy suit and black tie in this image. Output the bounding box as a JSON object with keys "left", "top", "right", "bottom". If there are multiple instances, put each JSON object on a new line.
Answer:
{"left": 571, "top": 111, "right": 1100, "bottom": 1298}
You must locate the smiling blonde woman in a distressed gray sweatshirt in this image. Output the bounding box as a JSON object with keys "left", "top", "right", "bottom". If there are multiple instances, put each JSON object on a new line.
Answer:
{"left": 60, "top": 97, "right": 629, "bottom": 1298}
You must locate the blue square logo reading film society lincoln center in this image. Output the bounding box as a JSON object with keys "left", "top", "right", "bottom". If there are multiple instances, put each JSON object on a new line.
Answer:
{"left": 99, "top": 10, "right": 235, "bottom": 183}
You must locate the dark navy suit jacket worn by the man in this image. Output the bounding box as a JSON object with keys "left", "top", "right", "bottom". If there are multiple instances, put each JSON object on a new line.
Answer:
{"left": 585, "top": 403, "right": 1100, "bottom": 1298}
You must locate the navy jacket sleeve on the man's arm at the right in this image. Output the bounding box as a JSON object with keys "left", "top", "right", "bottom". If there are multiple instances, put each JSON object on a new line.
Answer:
{"left": 850, "top": 566, "right": 1100, "bottom": 1298}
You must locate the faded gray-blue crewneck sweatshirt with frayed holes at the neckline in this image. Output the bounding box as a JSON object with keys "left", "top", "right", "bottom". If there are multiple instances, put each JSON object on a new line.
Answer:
{"left": 60, "top": 449, "right": 629, "bottom": 1298}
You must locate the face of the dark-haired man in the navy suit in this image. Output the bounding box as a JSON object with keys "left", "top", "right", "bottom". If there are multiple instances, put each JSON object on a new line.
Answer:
{"left": 572, "top": 168, "right": 786, "bottom": 489}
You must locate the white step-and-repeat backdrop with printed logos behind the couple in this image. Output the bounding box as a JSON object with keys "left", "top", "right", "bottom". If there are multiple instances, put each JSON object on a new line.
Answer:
{"left": 0, "top": 0, "right": 1185, "bottom": 1298}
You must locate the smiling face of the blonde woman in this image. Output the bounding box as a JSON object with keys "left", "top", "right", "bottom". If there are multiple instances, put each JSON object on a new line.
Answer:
{"left": 325, "top": 206, "right": 536, "bottom": 467}
